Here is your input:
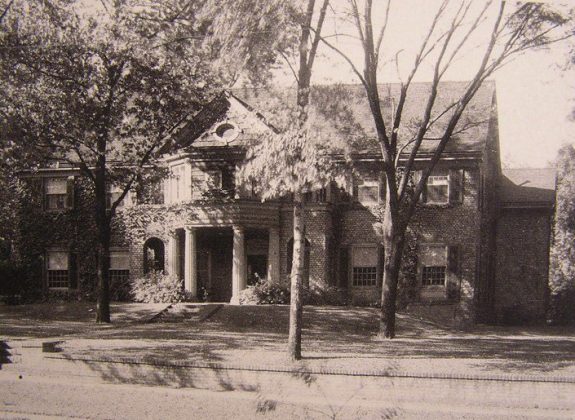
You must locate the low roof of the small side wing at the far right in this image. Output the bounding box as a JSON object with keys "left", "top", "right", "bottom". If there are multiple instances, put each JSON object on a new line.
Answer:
{"left": 498, "top": 168, "right": 555, "bottom": 207}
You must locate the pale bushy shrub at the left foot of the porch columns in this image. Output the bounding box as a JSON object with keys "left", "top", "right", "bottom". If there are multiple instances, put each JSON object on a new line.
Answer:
{"left": 131, "top": 271, "right": 190, "bottom": 303}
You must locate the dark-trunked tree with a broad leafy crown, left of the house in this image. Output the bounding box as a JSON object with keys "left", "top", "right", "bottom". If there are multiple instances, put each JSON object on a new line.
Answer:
{"left": 0, "top": 0, "right": 217, "bottom": 322}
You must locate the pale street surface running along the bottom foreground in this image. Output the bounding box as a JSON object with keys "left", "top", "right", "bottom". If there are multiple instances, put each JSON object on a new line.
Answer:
{"left": 0, "top": 370, "right": 575, "bottom": 419}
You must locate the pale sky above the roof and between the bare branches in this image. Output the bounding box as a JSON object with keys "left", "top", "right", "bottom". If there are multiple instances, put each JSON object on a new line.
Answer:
{"left": 272, "top": 0, "right": 575, "bottom": 167}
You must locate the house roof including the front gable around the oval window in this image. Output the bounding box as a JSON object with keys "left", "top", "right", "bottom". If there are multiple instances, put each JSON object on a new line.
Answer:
{"left": 161, "top": 82, "right": 496, "bottom": 157}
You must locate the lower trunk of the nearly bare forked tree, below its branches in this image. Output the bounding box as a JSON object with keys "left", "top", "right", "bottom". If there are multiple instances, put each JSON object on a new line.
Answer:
{"left": 379, "top": 200, "right": 405, "bottom": 338}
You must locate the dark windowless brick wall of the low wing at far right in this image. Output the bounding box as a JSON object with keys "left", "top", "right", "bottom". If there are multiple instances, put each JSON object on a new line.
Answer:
{"left": 494, "top": 209, "right": 550, "bottom": 323}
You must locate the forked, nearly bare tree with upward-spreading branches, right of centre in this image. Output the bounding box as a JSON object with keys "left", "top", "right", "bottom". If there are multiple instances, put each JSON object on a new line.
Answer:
{"left": 322, "top": 0, "right": 567, "bottom": 338}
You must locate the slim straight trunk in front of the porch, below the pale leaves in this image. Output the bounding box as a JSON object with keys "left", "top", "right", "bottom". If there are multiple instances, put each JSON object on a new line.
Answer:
{"left": 288, "top": 193, "right": 305, "bottom": 360}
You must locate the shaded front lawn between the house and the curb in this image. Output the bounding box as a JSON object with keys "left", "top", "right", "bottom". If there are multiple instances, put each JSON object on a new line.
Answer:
{"left": 0, "top": 303, "right": 575, "bottom": 379}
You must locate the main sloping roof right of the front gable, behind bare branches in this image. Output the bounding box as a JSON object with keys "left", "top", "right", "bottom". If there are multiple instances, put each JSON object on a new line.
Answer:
{"left": 234, "top": 81, "right": 497, "bottom": 156}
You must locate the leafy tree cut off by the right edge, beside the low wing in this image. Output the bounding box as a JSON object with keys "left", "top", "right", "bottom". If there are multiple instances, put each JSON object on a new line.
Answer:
{"left": 549, "top": 145, "right": 575, "bottom": 322}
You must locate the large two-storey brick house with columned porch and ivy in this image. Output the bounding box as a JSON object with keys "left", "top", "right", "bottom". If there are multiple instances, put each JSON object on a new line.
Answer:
{"left": 18, "top": 83, "right": 554, "bottom": 322}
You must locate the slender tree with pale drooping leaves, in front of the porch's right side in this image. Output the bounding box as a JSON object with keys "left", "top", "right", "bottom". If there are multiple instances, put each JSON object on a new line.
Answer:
{"left": 207, "top": 0, "right": 329, "bottom": 360}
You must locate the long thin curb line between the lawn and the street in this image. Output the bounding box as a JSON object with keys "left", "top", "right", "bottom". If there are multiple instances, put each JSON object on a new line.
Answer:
{"left": 45, "top": 355, "right": 575, "bottom": 384}
